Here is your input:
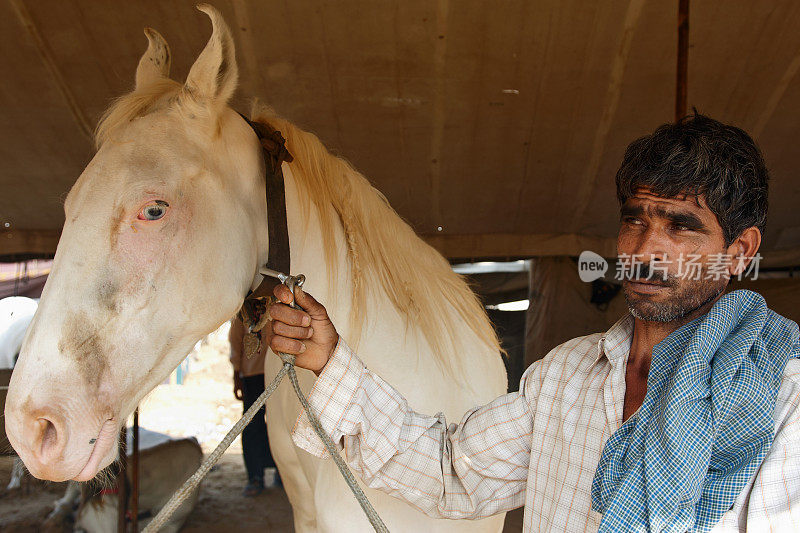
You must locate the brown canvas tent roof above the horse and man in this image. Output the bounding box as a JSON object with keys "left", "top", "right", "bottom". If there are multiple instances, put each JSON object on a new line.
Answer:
{"left": 0, "top": 0, "right": 800, "bottom": 265}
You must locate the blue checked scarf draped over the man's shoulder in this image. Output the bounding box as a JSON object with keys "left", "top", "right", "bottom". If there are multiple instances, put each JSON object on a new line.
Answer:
{"left": 592, "top": 290, "right": 800, "bottom": 532}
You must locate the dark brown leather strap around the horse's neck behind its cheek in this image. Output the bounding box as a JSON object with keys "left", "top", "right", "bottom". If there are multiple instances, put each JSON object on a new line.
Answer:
{"left": 239, "top": 115, "right": 293, "bottom": 344}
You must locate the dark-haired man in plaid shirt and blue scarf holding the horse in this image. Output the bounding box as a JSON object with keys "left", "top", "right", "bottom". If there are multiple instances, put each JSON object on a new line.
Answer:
{"left": 270, "top": 114, "right": 800, "bottom": 531}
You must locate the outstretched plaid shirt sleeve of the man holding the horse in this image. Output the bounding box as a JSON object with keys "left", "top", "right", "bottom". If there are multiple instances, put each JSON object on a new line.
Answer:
{"left": 293, "top": 340, "right": 539, "bottom": 519}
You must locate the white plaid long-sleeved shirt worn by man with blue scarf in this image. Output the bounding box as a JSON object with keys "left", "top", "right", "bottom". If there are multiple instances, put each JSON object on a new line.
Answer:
{"left": 293, "top": 315, "right": 800, "bottom": 533}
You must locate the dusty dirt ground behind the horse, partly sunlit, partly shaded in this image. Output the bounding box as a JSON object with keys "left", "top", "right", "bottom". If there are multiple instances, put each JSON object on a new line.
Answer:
{"left": 0, "top": 327, "right": 522, "bottom": 533}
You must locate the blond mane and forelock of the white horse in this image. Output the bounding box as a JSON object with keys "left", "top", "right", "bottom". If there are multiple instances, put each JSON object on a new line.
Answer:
{"left": 95, "top": 85, "right": 503, "bottom": 372}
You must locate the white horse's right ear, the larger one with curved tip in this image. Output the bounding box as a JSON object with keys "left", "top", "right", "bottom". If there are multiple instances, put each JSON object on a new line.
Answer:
{"left": 185, "top": 4, "right": 239, "bottom": 103}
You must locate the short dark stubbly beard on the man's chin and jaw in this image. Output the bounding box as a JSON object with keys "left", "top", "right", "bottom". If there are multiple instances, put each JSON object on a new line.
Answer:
{"left": 623, "top": 264, "right": 728, "bottom": 322}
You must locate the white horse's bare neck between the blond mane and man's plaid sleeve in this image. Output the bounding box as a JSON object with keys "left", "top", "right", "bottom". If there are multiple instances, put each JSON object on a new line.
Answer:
{"left": 272, "top": 164, "right": 506, "bottom": 410}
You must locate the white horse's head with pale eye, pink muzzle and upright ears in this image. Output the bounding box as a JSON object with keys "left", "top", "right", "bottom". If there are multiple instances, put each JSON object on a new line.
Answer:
{"left": 5, "top": 6, "right": 267, "bottom": 481}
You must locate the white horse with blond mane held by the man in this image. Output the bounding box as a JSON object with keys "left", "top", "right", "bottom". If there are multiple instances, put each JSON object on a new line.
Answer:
{"left": 6, "top": 6, "right": 506, "bottom": 532}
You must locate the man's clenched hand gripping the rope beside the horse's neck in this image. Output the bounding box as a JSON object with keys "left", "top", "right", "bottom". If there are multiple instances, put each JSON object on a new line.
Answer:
{"left": 269, "top": 284, "right": 339, "bottom": 376}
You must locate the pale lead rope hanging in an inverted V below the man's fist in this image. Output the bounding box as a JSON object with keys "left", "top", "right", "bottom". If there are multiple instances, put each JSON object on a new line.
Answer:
{"left": 148, "top": 352, "right": 389, "bottom": 533}
